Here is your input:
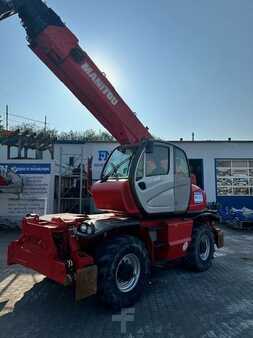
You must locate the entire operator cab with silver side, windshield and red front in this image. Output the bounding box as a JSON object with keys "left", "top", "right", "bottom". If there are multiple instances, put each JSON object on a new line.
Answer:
{"left": 92, "top": 140, "right": 191, "bottom": 215}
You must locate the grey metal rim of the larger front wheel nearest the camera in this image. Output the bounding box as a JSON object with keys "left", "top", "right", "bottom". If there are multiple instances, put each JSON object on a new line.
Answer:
{"left": 116, "top": 253, "right": 141, "bottom": 293}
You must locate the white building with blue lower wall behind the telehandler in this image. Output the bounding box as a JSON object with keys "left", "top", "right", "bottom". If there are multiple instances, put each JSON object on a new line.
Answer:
{"left": 0, "top": 140, "right": 253, "bottom": 227}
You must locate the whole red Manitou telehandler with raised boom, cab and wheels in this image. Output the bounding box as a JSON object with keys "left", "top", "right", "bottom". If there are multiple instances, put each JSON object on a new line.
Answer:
{"left": 0, "top": 0, "right": 223, "bottom": 309}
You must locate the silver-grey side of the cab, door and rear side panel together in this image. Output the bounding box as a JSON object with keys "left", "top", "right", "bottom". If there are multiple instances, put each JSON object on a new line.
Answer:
{"left": 130, "top": 142, "right": 191, "bottom": 214}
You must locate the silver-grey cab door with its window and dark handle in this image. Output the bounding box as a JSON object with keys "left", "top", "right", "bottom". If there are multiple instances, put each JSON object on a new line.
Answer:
{"left": 134, "top": 143, "right": 175, "bottom": 214}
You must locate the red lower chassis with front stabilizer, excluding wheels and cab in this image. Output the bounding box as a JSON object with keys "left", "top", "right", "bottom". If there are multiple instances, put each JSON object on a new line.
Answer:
{"left": 8, "top": 203, "right": 223, "bottom": 299}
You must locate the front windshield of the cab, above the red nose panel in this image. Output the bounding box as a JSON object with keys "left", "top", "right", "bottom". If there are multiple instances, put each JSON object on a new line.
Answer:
{"left": 102, "top": 147, "right": 135, "bottom": 180}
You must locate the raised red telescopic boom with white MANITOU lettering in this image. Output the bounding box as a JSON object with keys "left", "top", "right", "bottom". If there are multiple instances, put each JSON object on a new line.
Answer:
{"left": 0, "top": 0, "right": 151, "bottom": 144}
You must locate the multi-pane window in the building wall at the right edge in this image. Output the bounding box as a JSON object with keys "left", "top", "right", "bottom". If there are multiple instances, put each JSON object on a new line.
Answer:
{"left": 216, "top": 159, "right": 253, "bottom": 196}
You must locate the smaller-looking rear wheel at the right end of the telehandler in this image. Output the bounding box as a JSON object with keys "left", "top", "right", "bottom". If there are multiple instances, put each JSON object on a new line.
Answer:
{"left": 185, "top": 224, "right": 214, "bottom": 272}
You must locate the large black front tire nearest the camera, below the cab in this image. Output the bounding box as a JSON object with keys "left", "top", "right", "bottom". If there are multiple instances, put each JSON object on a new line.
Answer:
{"left": 96, "top": 235, "right": 150, "bottom": 310}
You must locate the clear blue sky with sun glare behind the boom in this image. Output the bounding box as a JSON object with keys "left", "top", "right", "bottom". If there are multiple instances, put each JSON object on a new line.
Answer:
{"left": 0, "top": 0, "right": 253, "bottom": 140}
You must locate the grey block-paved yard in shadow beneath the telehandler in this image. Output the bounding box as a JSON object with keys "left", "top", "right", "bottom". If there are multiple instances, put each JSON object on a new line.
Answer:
{"left": 0, "top": 229, "right": 253, "bottom": 338}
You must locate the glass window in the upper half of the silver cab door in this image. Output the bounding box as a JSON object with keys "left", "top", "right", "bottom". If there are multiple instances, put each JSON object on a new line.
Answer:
{"left": 145, "top": 146, "right": 170, "bottom": 177}
